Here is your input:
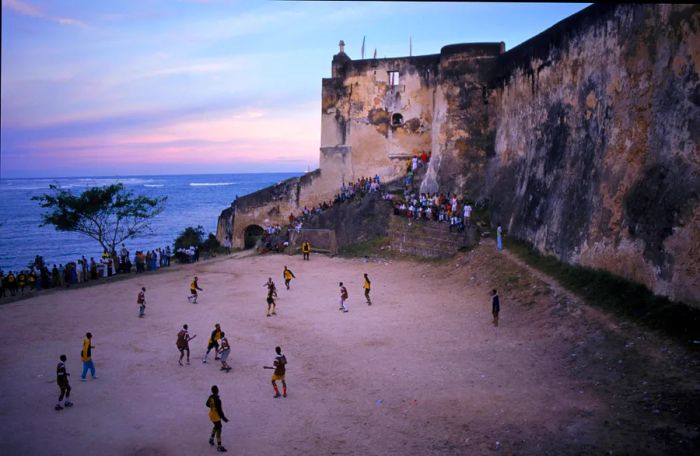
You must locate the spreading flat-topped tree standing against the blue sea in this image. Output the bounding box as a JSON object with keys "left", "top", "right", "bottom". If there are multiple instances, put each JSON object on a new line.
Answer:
{"left": 32, "top": 183, "right": 167, "bottom": 253}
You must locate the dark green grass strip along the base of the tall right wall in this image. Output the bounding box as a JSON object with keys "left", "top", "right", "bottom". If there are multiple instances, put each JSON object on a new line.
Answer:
{"left": 507, "top": 238, "right": 700, "bottom": 348}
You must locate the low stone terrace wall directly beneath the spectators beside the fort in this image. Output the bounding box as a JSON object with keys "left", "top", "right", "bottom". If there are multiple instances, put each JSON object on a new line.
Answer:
{"left": 388, "top": 215, "right": 478, "bottom": 258}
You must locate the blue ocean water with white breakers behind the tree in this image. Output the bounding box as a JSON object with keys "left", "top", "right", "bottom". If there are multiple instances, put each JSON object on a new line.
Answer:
{"left": 0, "top": 173, "right": 301, "bottom": 272}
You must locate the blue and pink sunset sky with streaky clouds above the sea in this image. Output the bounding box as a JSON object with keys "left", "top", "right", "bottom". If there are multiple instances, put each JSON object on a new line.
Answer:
{"left": 0, "top": 0, "right": 587, "bottom": 178}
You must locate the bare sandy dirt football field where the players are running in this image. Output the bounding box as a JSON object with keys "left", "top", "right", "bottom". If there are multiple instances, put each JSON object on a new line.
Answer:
{"left": 0, "top": 242, "right": 700, "bottom": 456}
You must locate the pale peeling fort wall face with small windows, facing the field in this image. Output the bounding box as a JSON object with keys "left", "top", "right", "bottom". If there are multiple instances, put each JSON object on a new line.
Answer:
{"left": 321, "top": 55, "right": 439, "bottom": 187}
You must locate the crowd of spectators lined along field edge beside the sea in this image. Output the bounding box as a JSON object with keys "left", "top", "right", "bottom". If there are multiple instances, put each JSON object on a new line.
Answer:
{"left": 0, "top": 244, "right": 172, "bottom": 298}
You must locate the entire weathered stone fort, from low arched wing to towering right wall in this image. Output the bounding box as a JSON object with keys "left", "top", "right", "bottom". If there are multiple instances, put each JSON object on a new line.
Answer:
{"left": 217, "top": 4, "right": 700, "bottom": 305}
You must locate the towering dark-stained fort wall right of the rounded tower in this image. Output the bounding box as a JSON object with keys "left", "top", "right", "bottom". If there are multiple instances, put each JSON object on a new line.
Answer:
{"left": 479, "top": 5, "right": 700, "bottom": 305}
